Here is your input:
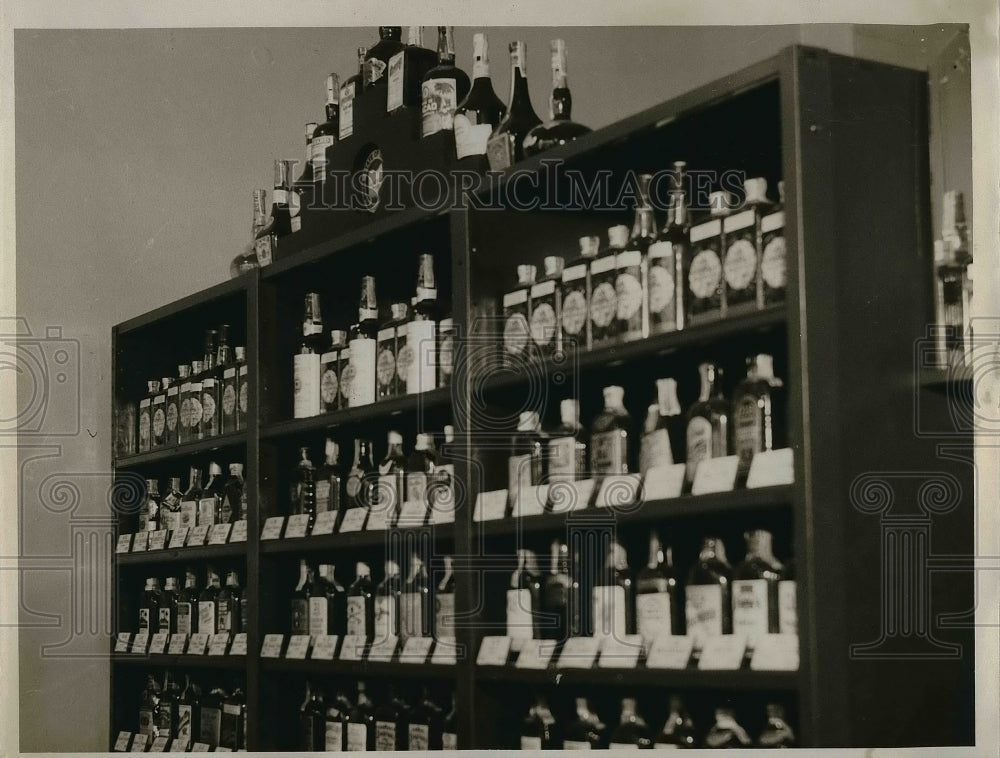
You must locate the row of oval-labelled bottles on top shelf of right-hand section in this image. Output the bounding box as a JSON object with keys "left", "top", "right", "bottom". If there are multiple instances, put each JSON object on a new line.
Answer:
{"left": 502, "top": 174, "right": 787, "bottom": 361}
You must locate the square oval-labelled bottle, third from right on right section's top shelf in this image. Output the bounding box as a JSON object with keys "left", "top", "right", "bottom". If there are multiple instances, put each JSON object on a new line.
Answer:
{"left": 685, "top": 192, "right": 728, "bottom": 326}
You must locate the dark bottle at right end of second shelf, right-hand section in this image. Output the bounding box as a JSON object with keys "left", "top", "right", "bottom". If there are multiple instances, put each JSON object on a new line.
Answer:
{"left": 733, "top": 353, "right": 784, "bottom": 482}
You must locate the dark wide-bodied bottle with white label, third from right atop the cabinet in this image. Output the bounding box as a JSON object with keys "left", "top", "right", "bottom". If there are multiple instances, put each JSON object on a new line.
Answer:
{"left": 455, "top": 32, "right": 507, "bottom": 172}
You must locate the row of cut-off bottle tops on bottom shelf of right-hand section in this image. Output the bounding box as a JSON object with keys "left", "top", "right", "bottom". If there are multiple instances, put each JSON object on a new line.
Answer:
{"left": 521, "top": 695, "right": 796, "bottom": 750}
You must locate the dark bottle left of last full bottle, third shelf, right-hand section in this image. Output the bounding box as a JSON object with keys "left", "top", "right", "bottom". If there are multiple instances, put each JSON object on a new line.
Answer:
{"left": 684, "top": 537, "right": 733, "bottom": 647}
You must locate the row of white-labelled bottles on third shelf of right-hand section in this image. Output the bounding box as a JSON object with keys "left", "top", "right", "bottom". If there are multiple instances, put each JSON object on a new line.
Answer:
{"left": 506, "top": 529, "right": 798, "bottom": 647}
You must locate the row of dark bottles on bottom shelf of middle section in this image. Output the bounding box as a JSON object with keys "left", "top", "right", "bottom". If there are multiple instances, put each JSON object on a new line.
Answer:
{"left": 297, "top": 681, "right": 458, "bottom": 752}
